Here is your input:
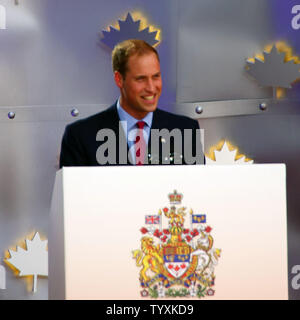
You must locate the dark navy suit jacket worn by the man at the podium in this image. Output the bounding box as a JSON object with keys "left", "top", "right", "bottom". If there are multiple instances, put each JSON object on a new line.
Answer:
{"left": 60, "top": 104, "right": 202, "bottom": 168}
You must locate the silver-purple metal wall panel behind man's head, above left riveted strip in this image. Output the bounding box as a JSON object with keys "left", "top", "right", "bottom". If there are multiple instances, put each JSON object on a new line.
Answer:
{"left": 0, "top": 0, "right": 177, "bottom": 106}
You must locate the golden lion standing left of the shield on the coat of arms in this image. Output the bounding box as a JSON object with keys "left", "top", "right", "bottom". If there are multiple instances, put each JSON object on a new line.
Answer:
{"left": 132, "top": 237, "right": 164, "bottom": 282}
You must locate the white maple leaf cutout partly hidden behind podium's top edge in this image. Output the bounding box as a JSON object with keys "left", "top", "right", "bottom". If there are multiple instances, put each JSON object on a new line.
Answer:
{"left": 205, "top": 141, "right": 253, "bottom": 165}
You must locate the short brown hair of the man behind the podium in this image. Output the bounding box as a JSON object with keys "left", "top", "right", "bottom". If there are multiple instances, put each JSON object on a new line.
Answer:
{"left": 112, "top": 39, "right": 159, "bottom": 78}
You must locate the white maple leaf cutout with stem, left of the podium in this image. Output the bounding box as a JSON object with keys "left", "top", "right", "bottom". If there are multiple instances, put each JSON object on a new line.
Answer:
{"left": 6, "top": 232, "right": 48, "bottom": 292}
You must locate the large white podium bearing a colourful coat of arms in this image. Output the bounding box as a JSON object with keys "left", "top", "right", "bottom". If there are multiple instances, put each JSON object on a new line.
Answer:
{"left": 49, "top": 164, "right": 288, "bottom": 300}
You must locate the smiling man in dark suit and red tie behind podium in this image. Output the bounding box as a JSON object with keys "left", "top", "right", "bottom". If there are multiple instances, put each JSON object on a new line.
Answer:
{"left": 60, "top": 40, "right": 203, "bottom": 167}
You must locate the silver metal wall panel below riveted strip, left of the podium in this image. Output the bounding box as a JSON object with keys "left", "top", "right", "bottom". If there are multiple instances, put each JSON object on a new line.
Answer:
{"left": 0, "top": 120, "right": 61, "bottom": 299}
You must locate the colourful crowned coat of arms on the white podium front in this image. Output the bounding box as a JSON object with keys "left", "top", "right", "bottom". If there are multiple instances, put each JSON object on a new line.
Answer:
{"left": 132, "top": 191, "right": 221, "bottom": 298}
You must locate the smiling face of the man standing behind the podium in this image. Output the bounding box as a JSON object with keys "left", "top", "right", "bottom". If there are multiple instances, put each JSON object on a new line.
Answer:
{"left": 115, "top": 52, "right": 162, "bottom": 119}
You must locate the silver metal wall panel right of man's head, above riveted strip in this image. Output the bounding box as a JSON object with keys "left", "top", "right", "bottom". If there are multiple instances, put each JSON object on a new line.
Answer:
{"left": 177, "top": 0, "right": 273, "bottom": 103}
